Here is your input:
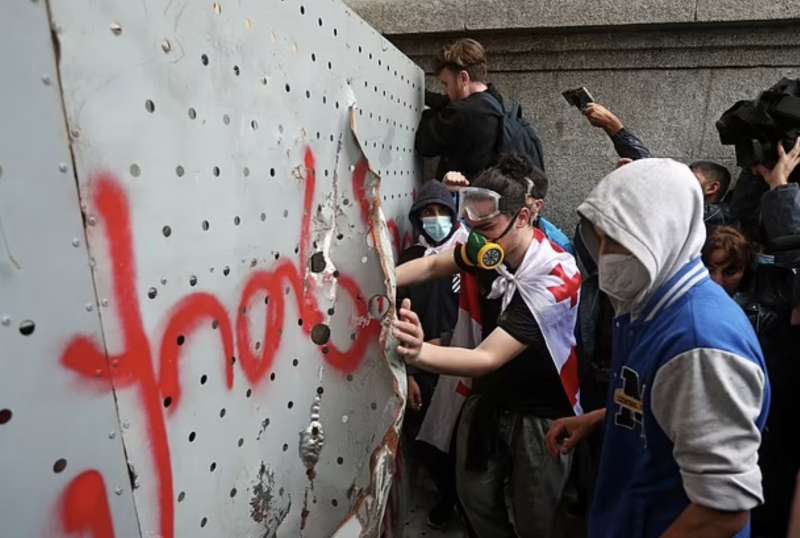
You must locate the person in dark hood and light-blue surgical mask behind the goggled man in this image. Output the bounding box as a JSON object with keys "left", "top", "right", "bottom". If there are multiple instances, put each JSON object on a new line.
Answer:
{"left": 397, "top": 179, "right": 463, "bottom": 528}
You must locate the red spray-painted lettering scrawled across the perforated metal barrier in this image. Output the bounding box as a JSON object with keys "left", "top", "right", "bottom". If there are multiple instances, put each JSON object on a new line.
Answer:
{"left": 61, "top": 149, "right": 388, "bottom": 538}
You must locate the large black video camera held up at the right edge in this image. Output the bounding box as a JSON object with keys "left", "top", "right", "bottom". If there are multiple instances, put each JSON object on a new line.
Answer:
{"left": 717, "top": 78, "right": 800, "bottom": 181}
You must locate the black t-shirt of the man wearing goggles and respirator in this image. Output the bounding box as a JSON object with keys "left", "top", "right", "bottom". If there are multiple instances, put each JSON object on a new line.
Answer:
{"left": 455, "top": 249, "right": 573, "bottom": 418}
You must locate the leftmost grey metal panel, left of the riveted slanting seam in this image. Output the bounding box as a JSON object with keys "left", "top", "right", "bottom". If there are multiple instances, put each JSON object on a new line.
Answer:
{"left": 0, "top": 0, "right": 138, "bottom": 538}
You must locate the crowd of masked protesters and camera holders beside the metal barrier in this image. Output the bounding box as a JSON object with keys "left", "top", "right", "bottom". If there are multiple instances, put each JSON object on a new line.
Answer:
{"left": 393, "top": 39, "right": 800, "bottom": 538}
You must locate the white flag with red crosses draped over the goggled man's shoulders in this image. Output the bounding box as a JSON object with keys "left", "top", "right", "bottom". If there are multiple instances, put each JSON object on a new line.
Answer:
{"left": 417, "top": 228, "right": 583, "bottom": 452}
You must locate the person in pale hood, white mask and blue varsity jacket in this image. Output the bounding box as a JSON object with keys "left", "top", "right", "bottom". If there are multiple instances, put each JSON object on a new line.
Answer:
{"left": 547, "top": 159, "right": 770, "bottom": 538}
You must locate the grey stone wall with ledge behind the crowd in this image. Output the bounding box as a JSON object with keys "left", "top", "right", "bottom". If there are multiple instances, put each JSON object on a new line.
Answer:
{"left": 348, "top": 0, "right": 800, "bottom": 230}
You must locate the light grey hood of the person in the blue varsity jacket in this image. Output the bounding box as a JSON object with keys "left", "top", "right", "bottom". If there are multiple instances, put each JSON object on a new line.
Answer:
{"left": 578, "top": 159, "right": 706, "bottom": 314}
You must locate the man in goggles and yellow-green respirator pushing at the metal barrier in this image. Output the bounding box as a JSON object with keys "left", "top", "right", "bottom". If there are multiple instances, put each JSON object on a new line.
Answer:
{"left": 394, "top": 166, "right": 580, "bottom": 538}
